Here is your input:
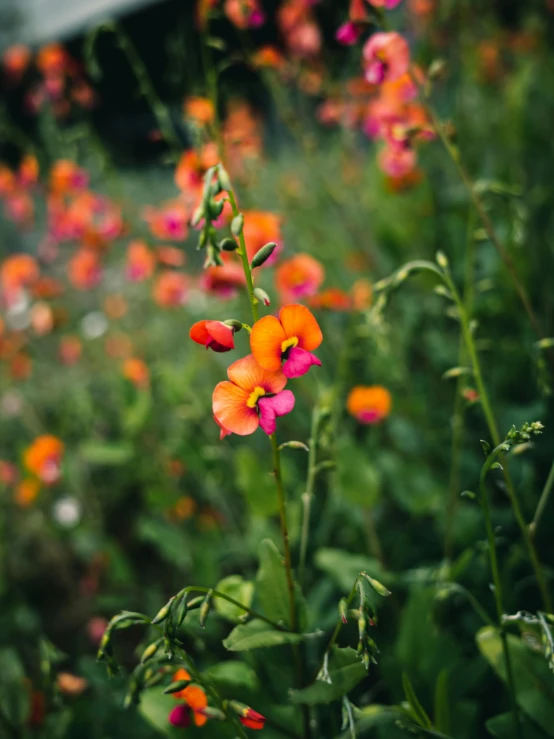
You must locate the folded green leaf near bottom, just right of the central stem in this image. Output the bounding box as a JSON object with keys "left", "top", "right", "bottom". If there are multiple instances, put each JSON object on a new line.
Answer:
{"left": 291, "top": 647, "right": 367, "bottom": 706}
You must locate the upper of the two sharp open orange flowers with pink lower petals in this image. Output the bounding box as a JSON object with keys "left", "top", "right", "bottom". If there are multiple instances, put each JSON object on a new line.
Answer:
{"left": 250, "top": 305, "right": 323, "bottom": 378}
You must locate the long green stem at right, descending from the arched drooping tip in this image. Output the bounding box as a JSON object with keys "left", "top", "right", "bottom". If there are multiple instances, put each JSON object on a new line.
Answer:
{"left": 443, "top": 269, "right": 552, "bottom": 613}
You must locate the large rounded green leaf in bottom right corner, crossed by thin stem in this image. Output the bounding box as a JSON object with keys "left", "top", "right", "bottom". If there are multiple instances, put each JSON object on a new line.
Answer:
{"left": 477, "top": 626, "right": 554, "bottom": 736}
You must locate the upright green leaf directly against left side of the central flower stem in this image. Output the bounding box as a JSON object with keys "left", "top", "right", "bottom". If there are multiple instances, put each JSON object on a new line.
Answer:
{"left": 256, "top": 539, "right": 290, "bottom": 626}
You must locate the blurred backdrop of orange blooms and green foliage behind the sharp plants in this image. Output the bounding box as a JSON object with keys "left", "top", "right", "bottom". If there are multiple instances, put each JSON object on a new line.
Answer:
{"left": 0, "top": 0, "right": 554, "bottom": 739}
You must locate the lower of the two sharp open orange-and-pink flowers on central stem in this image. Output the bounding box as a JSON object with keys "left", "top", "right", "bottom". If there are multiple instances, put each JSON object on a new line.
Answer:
{"left": 212, "top": 354, "right": 294, "bottom": 436}
